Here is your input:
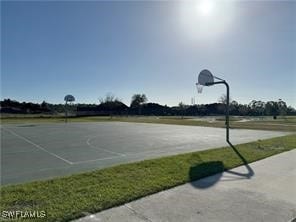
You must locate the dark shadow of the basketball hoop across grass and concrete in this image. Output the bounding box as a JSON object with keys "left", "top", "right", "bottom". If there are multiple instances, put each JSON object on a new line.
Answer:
{"left": 189, "top": 141, "right": 255, "bottom": 189}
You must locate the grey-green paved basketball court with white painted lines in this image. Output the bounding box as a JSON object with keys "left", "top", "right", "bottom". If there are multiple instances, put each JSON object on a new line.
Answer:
{"left": 1, "top": 122, "right": 287, "bottom": 184}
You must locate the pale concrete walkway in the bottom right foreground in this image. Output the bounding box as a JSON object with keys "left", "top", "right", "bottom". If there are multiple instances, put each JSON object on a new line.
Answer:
{"left": 77, "top": 150, "right": 296, "bottom": 222}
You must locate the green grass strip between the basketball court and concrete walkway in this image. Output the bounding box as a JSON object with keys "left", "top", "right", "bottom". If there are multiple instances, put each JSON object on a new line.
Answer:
{"left": 0, "top": 135, "right": 296, "bottom": 221}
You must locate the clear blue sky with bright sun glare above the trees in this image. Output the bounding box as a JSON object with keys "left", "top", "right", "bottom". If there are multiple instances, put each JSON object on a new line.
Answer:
{"left": 1, "top": 1, "right": 296, "bottom": 107}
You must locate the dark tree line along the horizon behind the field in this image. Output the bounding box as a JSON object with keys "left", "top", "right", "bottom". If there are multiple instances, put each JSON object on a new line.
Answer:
{"left": 0, "top": 94, "right": 296, "bottom": 117}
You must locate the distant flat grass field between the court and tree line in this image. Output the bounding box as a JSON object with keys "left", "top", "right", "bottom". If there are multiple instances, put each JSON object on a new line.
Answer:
{"left": 1, "top": 116, "right": 296, "bottom": 132}
